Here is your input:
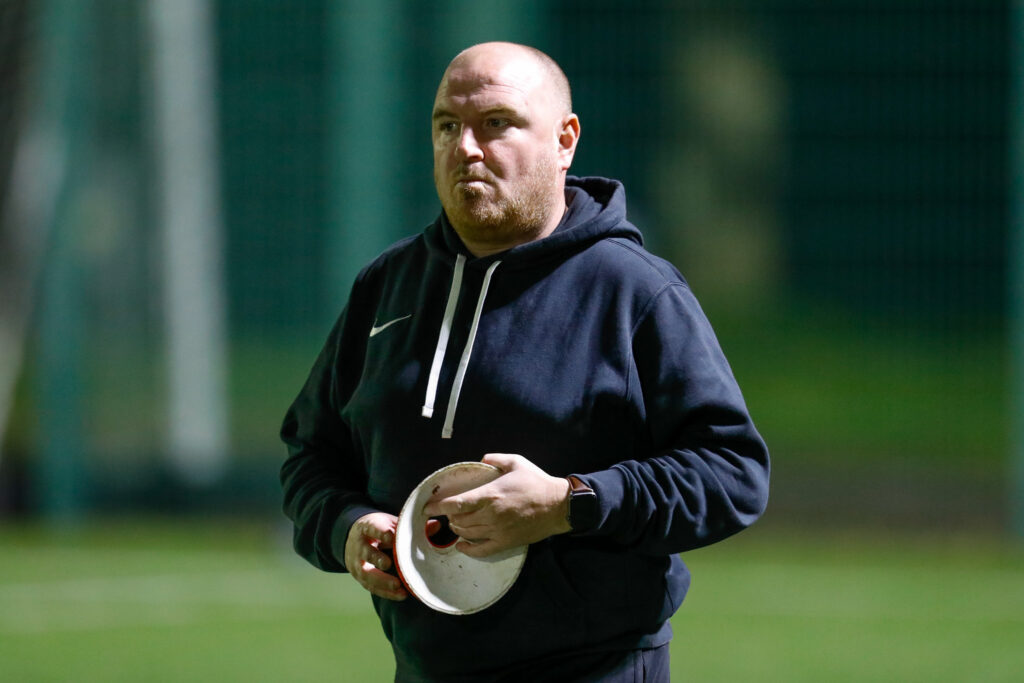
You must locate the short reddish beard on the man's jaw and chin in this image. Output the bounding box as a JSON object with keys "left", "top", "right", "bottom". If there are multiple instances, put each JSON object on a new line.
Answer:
{"left": 434, "top": 153, "right": 559, "bottom": 248}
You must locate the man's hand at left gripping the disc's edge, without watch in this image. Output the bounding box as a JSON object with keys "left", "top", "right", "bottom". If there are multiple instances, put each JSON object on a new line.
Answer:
{"left": 345, "top": 512, "right": 409, "bottom": 600}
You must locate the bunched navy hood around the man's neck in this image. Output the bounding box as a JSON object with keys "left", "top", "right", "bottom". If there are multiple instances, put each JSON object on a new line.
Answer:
{"left": 425, "top": 175, "right": 643, "bottom": 270}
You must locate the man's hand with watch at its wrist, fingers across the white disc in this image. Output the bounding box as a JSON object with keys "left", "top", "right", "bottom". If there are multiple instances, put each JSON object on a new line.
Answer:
{"left": 423, "top": 453, "right": 571, "bottom": 557}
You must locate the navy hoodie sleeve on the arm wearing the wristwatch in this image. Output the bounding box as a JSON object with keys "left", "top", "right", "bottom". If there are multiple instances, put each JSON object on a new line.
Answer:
{"left": 580, "top": 283, "right": 769, "bottom": 555}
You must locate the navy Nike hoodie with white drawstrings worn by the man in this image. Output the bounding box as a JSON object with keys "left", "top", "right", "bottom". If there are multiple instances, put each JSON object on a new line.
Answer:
{"left": 282, "top": 176, "right": 769, "bottom": 681}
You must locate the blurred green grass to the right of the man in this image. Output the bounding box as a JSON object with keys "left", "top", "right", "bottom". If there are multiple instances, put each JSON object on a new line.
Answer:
{"left": 674, "top": 528, "right": 1024, "bottom": 682}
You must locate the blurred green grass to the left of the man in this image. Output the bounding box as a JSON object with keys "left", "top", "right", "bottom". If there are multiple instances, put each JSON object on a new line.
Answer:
{"left": 0, "top": 521, "right": 393, "bottom": 681}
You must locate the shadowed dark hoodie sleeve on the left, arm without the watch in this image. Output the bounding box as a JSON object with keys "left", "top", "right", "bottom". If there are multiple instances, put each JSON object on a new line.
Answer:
{"left": 281, "top": 292, "right": 377, "bottom": 571}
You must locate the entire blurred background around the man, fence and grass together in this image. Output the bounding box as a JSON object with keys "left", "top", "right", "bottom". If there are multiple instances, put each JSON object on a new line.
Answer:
{"left": 0, "top": 0, "right": 1024, "bottom": 682}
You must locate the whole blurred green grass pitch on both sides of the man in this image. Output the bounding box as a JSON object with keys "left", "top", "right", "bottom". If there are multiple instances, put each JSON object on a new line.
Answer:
{"left": 0, "top": 518, "right": 1024, "bottom": 682}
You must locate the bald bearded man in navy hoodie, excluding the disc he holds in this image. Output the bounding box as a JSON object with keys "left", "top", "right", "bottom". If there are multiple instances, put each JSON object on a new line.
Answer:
{"left": 282, "top": 43, "right": 768, "bottom": 681}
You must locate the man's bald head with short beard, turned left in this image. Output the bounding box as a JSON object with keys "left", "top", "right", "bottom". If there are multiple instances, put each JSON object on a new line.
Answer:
{"left": 431, "top": 43, "right": 580, "bottom": 256}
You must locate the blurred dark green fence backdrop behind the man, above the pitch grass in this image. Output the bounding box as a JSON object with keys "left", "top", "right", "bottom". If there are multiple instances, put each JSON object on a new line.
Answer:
{"left": 0, "top": 0, "right": 1024, "bottom": 533}
